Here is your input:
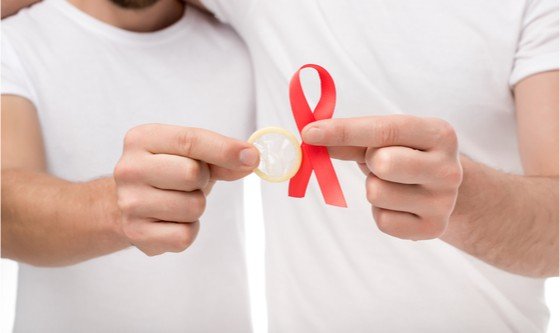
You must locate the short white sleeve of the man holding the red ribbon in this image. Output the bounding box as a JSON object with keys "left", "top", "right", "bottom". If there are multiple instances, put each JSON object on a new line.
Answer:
{"left": 509, "top": 0, "right": 559, "bottom": 87}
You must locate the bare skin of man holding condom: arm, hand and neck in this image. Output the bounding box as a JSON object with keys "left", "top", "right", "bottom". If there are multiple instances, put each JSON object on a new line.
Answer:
{"left": 1, "top": 0, "right": 258, "bottom": 266}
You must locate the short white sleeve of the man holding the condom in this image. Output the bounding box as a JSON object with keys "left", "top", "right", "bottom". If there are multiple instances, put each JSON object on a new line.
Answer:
{"left": 0, "top": 36, "right": 37, "bottom": 105}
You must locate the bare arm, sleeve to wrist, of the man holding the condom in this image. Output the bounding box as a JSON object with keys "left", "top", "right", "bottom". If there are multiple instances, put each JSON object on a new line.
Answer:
{"left": 2, "top": 95, "right": 129, "bottom": 266}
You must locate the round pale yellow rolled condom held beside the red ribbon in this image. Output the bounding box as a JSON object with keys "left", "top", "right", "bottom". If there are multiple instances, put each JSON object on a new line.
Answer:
{"left": 248, "top": 127, "right": 301, "bottom": 183}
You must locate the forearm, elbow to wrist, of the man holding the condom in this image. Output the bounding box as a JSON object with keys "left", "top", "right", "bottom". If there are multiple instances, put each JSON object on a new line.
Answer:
{"left": 2, "top": 170, "right": 129, "bottom": 266}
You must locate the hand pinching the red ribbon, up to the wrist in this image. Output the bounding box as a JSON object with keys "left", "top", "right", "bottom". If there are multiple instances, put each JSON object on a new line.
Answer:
{"left": 302, "top": 115, "right": 462, "bottom": 240}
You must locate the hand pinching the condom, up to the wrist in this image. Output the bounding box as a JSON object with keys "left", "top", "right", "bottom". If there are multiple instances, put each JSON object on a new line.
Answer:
{"left": 114, "top": 124, "right": 259, "bottom": 256}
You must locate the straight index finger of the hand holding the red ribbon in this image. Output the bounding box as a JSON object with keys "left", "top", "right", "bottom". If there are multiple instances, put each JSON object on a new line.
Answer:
{"left": 302, "top": 115, "right": 456, "bottom": 150}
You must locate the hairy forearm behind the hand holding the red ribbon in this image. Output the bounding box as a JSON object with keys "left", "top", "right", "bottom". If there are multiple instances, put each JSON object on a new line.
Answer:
{"left": 441, "top": 157, "right": 558, "bottom": 277}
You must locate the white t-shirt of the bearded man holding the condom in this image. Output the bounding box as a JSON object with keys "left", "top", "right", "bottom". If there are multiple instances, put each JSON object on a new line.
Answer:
{"left": 2, "top": 0, "right": 254, "bottom": 332}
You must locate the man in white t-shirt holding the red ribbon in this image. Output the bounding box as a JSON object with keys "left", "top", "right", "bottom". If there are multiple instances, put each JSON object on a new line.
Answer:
{"left": 195, "top": 0, "right": 558, "bottom": 333}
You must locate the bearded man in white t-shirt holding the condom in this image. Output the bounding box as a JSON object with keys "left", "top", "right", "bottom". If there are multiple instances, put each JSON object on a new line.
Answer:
{"left": 2, "top": 0, "right": 258, "bottom": 332}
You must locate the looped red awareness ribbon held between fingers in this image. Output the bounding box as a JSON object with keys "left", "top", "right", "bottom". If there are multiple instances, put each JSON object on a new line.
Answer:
{"left": 288, "top": 64, "right": 347, "bottom": 207}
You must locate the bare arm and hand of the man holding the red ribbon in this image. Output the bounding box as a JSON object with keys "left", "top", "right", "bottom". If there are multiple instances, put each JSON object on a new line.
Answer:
{"left": 3, "top": 1, "right": 559, "bottom": 277}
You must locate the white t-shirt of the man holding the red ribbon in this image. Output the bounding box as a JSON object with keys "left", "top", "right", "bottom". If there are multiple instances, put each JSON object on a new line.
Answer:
{"left": 205, "top": 0, "right": 558, "bottom": 333}
